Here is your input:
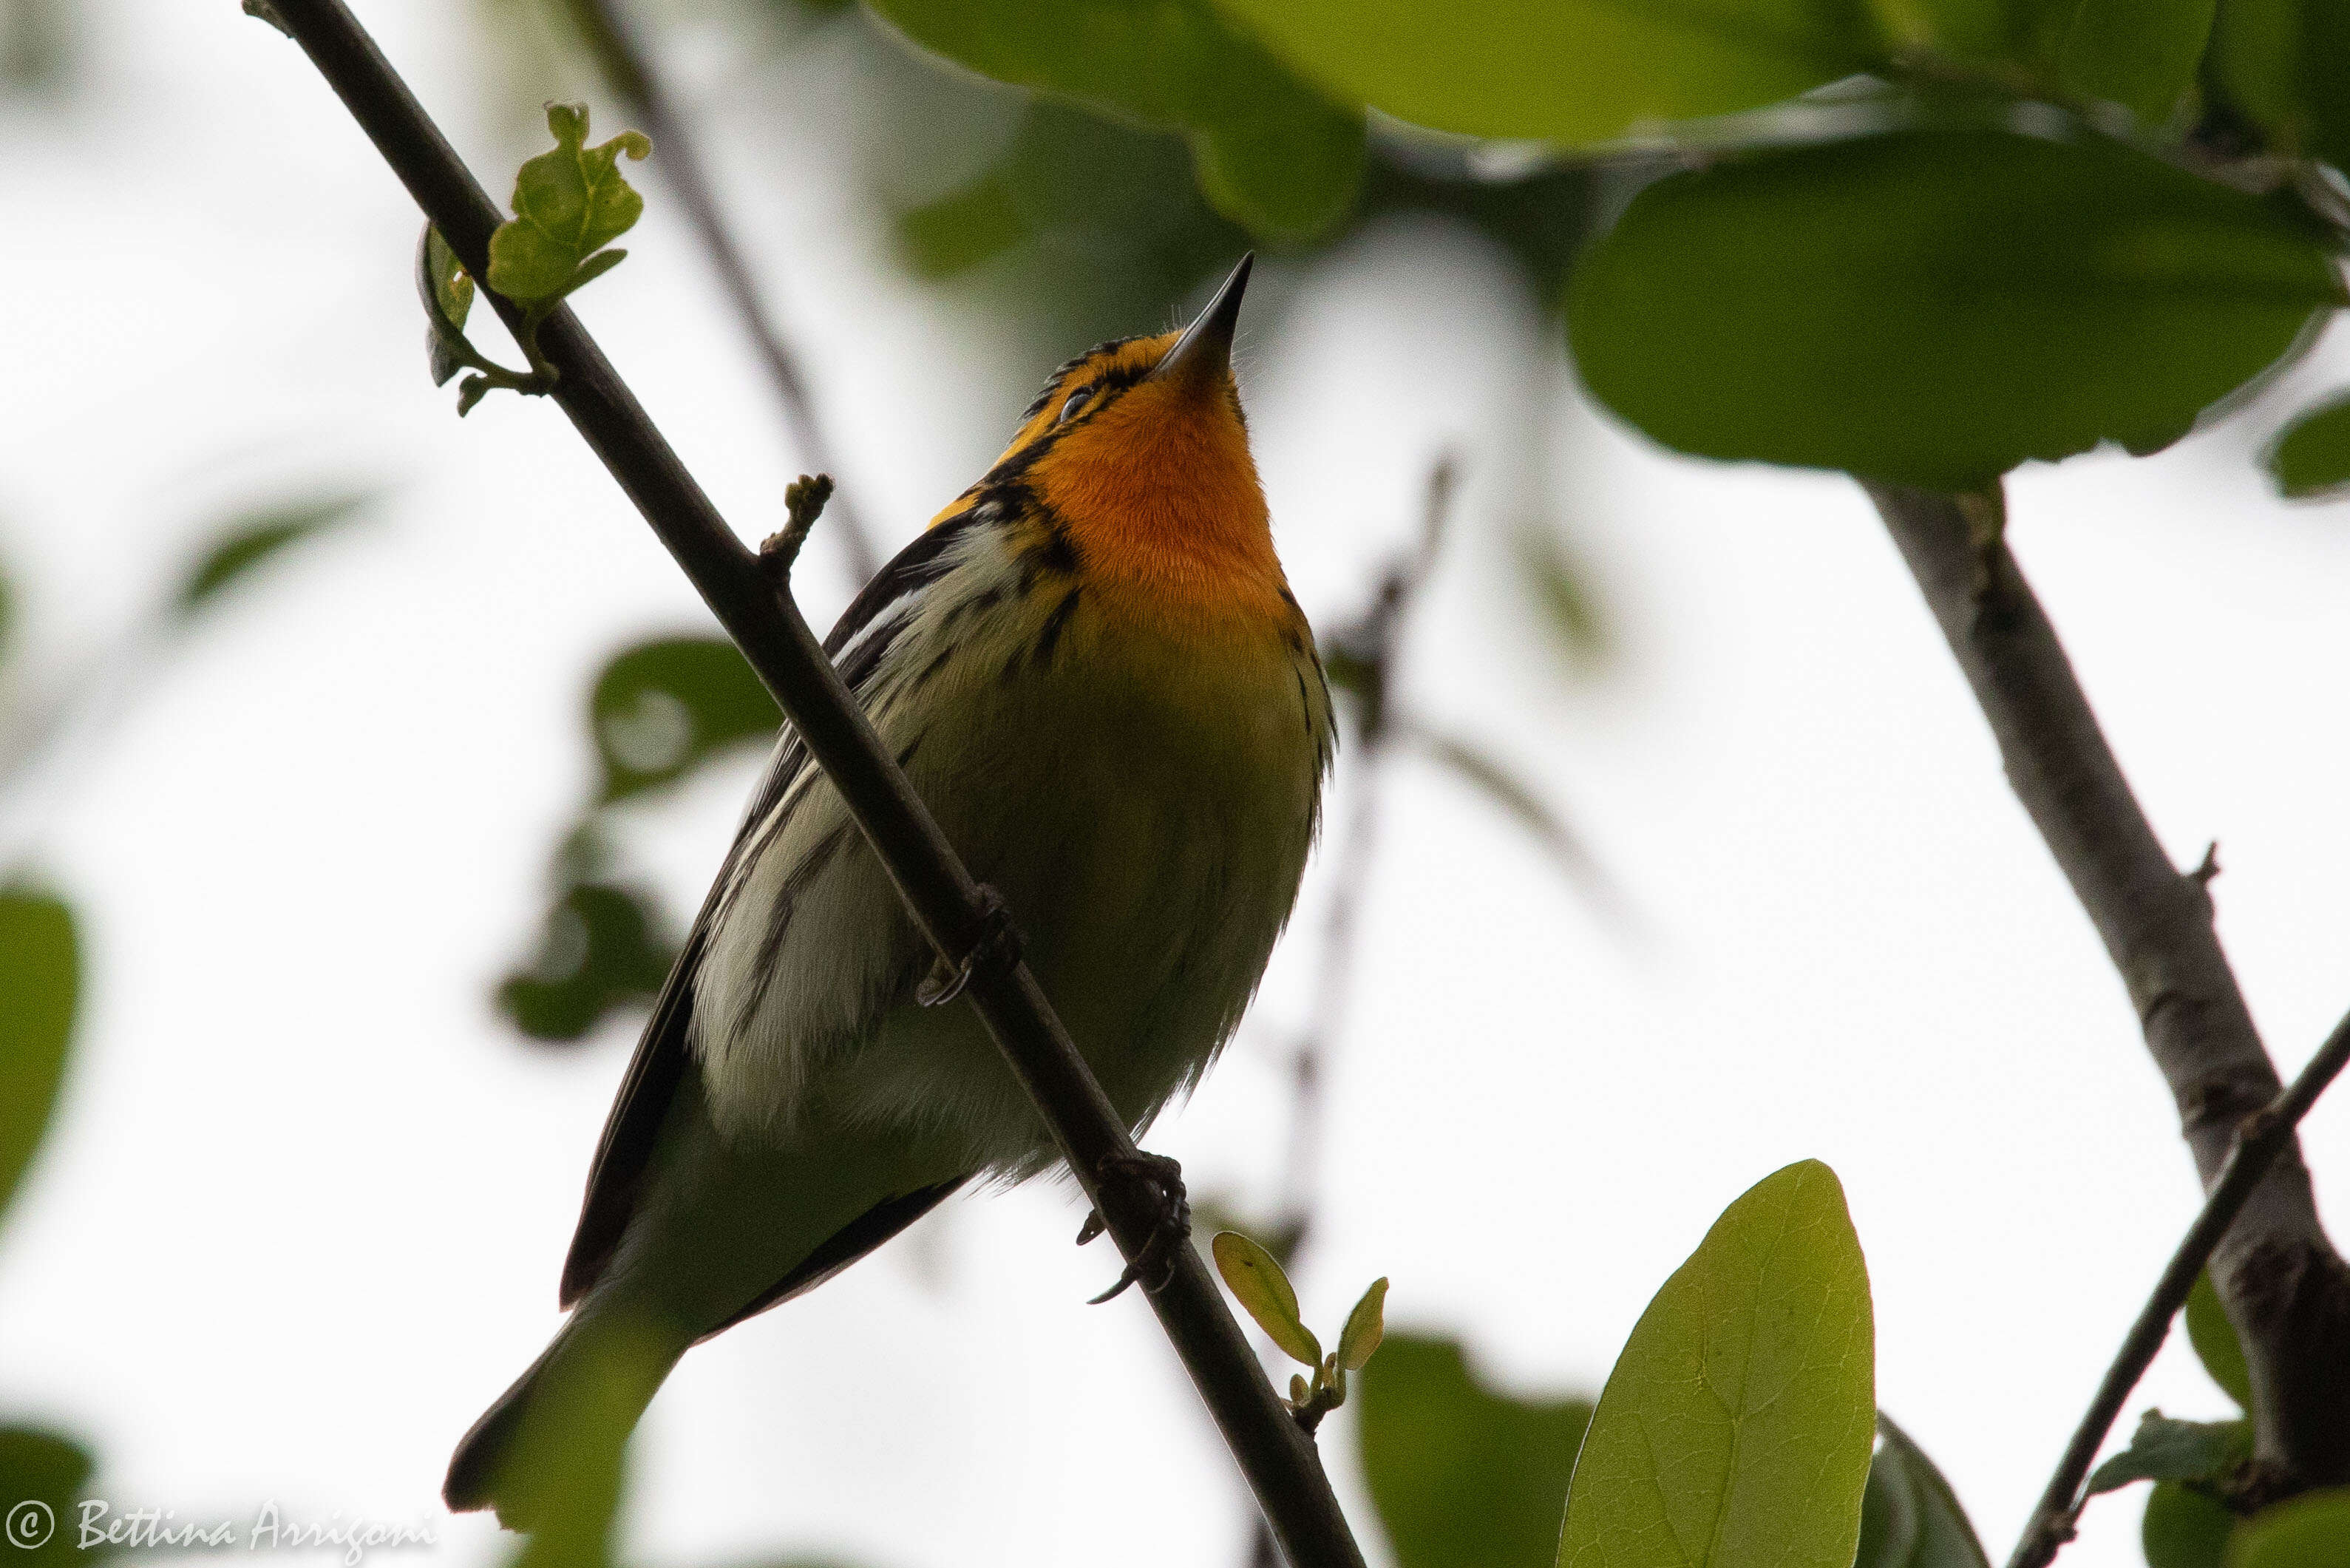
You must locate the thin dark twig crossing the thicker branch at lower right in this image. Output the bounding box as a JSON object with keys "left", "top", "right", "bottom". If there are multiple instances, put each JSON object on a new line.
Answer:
{"left": 2007, "top": 1018, "right": 2350, "bottom": 1568}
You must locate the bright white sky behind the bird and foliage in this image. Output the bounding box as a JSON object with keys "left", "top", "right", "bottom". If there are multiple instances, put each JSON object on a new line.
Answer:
{"left": 0, "top": 0, "right": 2350, "bottom": 1568}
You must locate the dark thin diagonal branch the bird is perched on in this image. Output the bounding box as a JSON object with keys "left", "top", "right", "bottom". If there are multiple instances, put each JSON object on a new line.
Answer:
{"left": 262, "top": 0, "right": 1363, "bottom": 1568}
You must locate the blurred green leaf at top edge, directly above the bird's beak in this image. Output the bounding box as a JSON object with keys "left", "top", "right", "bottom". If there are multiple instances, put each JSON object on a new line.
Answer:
{"left": 872, "top": 0, "right": 1363, "bottom": 240}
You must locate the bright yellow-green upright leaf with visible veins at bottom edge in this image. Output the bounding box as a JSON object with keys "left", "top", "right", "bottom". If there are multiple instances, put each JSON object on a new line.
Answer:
{"left": 1558, "top": 1159, "right": 1875, "bottom": 1568}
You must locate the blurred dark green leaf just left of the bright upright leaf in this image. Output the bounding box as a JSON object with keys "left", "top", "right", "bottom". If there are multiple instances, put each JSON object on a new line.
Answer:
{"left": 1356, "top": 1333, "right": 1591, "bottom": 1568}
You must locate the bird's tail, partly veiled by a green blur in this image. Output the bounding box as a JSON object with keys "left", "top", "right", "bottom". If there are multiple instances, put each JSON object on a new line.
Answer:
{"left": 442, "top": 1295, "right": 688, "bottom": 1530}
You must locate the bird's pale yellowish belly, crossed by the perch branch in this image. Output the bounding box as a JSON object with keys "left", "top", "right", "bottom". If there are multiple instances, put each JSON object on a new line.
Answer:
{"left": 690, "top": 606, "right": 1321, "bottom": 1175}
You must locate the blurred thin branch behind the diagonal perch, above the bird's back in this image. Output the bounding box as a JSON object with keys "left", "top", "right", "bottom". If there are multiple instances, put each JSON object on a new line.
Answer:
{"left": 564, "top": 0, "right": 881, "bottom": 586}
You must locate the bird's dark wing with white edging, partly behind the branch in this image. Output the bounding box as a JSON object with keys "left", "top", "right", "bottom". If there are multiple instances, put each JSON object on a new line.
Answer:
{"left": 557, "top": 512, "right": 982, "bottom": 1317}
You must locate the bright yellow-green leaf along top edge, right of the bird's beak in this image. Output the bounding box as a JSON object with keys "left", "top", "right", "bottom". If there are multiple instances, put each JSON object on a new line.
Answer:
{"left": 1218, "top": 0, "right": 1885, "bottom": 141}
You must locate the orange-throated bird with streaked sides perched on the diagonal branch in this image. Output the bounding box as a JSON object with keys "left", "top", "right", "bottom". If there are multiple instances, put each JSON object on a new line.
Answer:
{"left": 444, "top": 259, "right": 1332, "bottom": 1524}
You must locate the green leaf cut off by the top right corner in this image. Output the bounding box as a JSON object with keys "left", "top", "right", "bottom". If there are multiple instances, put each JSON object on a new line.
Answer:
{"left": 2211, "top": 0, "right": 2350, "bottom": 169}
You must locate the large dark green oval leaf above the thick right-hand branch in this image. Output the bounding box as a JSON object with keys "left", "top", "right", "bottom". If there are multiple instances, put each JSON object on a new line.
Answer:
{"left": 1567, "top": 132, "right": 2343, "bottom": 492}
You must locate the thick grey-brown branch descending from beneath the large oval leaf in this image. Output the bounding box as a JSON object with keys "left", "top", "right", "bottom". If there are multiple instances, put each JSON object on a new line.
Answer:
{"left": 1866, "top": 484, "right": 2350, "bottom": 1495}
